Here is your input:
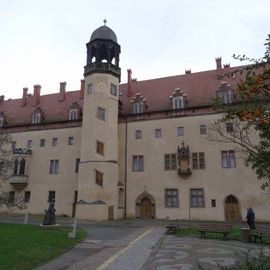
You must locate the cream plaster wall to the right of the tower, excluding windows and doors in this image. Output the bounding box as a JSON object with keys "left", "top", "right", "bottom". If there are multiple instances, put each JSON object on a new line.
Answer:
{"left": 119, "top": 114, "right": 270, "bottom": 221}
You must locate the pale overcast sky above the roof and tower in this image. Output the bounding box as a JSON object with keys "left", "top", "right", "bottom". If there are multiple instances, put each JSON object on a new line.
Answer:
{"left": 0, "top": 0, "right": 270, "bottom": 99}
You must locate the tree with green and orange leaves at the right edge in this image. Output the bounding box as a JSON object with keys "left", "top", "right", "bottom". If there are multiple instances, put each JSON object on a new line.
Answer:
{"left": 212, "top": 35, "right": 270, "bottom": 189}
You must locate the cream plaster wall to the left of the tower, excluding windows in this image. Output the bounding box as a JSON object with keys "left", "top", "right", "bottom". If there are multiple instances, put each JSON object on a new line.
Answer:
{"left": 3, "top": 127, "right": 81, "bottom": 215}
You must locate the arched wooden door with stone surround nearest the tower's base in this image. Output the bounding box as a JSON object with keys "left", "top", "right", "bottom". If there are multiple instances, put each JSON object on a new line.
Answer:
{"left": 136, "top": 192, "right": 155, "bottom": 218}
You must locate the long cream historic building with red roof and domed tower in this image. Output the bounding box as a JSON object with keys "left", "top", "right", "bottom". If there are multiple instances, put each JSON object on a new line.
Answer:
{"left": 0, "top": 25, "right": 270, "bottom": 221}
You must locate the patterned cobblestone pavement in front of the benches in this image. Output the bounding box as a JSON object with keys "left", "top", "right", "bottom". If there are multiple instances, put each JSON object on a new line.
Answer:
{"left": 145, "top": 235, "right": 270, "bottom": 270}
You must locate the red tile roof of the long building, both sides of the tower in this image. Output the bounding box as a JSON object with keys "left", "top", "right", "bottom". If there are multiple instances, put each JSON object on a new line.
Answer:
{"left": 0, "top": 65, "right": 247, "bottom": 125}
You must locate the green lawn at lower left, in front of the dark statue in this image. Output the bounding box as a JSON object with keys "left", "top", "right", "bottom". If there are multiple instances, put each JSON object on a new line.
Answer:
{"left": 0, "top": 224, "right": 86, "bottom": 270}
